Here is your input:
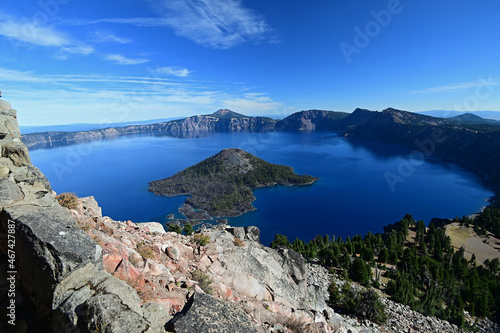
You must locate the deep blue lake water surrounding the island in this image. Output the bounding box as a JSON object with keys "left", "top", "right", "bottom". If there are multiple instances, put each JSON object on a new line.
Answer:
{"left": 30, "top": 132, "right": 493, "bottom": 245}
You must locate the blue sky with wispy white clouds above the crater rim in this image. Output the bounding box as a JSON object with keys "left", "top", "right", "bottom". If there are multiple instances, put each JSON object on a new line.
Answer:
{"left": 0, "top": 0, "right": 500, "bottom": 126}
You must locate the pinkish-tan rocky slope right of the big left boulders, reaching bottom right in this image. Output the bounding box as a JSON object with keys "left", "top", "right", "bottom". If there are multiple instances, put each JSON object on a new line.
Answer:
{"left": 68, "top": 198, "right": 498, "bottom": 333}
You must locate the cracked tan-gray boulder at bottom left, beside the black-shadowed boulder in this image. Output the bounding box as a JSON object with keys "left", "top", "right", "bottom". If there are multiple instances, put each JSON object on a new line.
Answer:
{"left": 52, "top": 263, "right": 172, "bottom": 333}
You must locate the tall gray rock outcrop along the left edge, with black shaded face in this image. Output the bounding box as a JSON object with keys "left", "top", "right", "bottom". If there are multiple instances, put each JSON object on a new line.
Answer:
{"left": 0, "top": 100, "right": 169, "bottom": 332}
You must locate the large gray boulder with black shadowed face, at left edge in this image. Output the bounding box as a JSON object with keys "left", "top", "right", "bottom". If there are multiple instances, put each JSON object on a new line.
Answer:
{"left": 2, "top": 206, "right": 102, "bottom": 317}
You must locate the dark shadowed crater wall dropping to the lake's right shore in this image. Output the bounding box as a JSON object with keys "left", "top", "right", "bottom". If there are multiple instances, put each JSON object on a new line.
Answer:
{"left": 343, "top": 109, "right": 500, "bottom": 192}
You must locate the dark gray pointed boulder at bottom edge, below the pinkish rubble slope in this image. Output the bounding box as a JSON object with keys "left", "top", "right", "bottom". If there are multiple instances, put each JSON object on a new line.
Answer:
{"left": 167, "top": 293, "right": 257, "bottom": 333}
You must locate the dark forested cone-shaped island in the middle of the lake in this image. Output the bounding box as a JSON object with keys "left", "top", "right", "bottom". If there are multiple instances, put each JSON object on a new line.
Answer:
{"left": 149, "top": 148, "right": 317, "bottom": 218}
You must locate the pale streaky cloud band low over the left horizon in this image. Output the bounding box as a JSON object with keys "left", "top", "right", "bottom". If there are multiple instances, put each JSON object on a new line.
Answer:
{"left": 0, "top": 67, "right": 282, "bottom": 126}
